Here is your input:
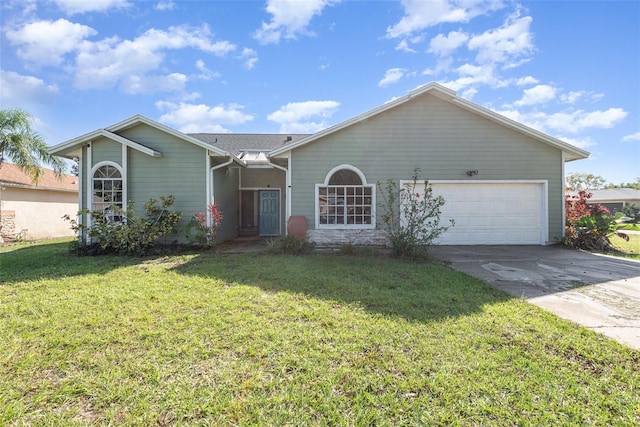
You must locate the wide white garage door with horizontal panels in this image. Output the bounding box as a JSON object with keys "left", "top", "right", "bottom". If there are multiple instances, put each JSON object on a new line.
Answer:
{"left": 410, "top": 181, "right": 547, "bottom": 245}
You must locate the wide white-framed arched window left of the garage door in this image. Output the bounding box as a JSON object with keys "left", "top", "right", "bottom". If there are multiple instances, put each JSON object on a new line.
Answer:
{"left": 316, "top": 165, "right": 375, "bottom": 228}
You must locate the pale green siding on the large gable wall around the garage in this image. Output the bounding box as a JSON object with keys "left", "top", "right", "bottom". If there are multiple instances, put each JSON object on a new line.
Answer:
{"left": 291, "top": 94, "right": 563, "bottom": 242}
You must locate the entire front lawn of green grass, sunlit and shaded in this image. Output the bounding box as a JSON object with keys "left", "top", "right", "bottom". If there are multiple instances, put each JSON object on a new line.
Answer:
{"left": 0, "top": 242, "right": 640, "bottom": 426}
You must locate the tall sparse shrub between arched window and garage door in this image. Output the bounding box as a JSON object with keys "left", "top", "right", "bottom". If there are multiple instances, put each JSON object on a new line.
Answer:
{"left": 377, "top": 168, "right": 454, "bottom": 258}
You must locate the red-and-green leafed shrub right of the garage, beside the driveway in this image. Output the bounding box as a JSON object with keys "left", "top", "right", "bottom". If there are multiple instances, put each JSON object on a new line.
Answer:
{"left": 562, "top": 190, "right": 629, "bottom": 251}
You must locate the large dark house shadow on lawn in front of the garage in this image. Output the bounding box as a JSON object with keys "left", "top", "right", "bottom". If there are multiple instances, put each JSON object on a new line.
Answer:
{"left": 172, "top": 253, "right": 510, "bottom": 322}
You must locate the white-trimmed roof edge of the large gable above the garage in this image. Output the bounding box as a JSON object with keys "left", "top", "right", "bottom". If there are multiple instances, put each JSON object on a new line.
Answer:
{"left": 269, "top": 82, "right": 589, "bottom": 161}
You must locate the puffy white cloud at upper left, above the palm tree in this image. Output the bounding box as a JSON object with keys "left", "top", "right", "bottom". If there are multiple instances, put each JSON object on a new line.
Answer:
{"left": 6, "top": 19, "right": 97, "bottom": 65}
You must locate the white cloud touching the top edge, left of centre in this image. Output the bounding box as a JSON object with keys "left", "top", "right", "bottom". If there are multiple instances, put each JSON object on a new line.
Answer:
{"left": 253, "top": 0, "right": 338, "bottom": 44}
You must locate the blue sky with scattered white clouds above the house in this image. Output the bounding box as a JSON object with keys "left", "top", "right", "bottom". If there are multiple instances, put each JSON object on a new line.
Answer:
{"left": 0, "top": 0, "right": 640, "bottom": 183}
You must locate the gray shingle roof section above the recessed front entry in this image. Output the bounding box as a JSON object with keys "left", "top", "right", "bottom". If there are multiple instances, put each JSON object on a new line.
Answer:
{"left": 188, "top": 133, "right": 309, "bottom": 156}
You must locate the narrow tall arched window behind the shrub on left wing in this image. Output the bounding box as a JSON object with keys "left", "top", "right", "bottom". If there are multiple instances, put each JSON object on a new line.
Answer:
{"left": 92, "top": 163, "right": 123, "bottom": 221}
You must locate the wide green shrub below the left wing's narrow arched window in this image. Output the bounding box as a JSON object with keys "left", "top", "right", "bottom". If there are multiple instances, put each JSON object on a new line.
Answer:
{"left": 63, "top": 196, "right": 181, "bottom": 255}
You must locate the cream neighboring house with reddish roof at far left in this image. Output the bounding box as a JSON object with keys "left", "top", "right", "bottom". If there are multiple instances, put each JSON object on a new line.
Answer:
{"left": 0, "top": 162, "right": 78, "bottom": 239}
